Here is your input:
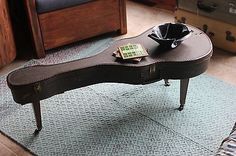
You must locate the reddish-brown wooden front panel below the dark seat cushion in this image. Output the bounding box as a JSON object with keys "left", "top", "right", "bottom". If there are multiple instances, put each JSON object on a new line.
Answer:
{"left": 39, "top": 0, "right": 121, "bottom": 49}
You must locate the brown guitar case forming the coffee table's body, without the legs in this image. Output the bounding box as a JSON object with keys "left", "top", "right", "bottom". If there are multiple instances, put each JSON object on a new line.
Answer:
{"left": 7, "top": 27, "right": 212, "bottom": 104}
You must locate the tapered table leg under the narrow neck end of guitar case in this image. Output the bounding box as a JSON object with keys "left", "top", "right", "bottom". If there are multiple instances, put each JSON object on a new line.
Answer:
{"left": 32, "top": 101, "right": 42, "bottom": 132}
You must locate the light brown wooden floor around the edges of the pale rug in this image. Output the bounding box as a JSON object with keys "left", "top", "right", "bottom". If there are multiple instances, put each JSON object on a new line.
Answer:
{"left": 0, "top": 1, "right": 236, "bottom": 156}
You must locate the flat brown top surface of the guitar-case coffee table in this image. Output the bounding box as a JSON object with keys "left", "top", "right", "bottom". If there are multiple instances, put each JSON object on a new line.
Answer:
{"left": 8, "top": 27, "right": 212, "bottom": 85}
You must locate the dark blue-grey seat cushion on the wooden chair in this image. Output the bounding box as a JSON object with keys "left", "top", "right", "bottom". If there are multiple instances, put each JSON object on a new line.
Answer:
{"left": 36, "top": 0, "right": 92, "bottom": 13}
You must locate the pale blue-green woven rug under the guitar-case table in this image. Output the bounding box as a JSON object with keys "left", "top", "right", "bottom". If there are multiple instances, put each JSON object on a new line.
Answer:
{"left": 0, "top": 39, "right": 236, "bottom": 156}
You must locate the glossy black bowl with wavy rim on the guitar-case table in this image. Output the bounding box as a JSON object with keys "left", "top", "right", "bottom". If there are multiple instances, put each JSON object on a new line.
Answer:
{"left": 148, "top": 23, "right": 192, "bottom": 49}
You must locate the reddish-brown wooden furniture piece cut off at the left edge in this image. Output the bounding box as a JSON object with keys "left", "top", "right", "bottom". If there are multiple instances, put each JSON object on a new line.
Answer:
{"left": 0, "top": 0, "right": 16, "bottom": 68}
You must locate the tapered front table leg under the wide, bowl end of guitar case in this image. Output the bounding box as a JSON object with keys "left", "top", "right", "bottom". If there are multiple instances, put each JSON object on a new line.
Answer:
{"left": 178, "top": 79, "right": 189, "bottom": 111}
